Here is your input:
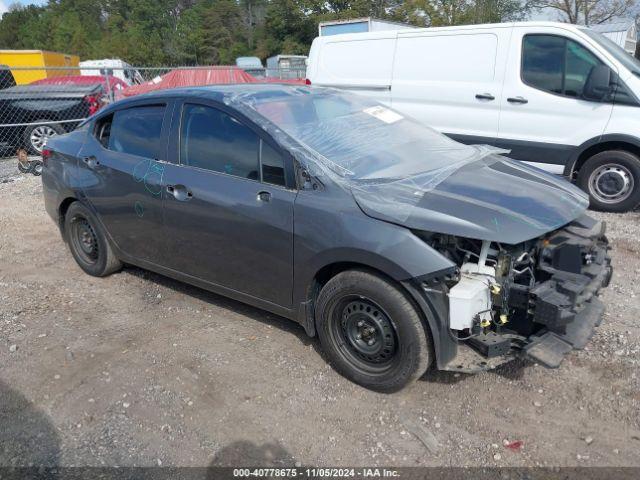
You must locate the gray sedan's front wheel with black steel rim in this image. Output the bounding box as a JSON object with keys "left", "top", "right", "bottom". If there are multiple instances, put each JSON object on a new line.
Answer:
{"left": 315, "top": 270, "right": 433, "bottom": 392}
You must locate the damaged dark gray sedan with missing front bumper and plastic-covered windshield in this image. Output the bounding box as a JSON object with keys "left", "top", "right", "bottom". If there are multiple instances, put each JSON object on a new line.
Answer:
{"left": 42, "top": 85, "right": 612, "bottom": 391}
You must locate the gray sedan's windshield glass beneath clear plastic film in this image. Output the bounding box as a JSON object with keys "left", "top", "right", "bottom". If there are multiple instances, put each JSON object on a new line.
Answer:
{"left": 246, "top": 88, "right": 482, "bottom": 180}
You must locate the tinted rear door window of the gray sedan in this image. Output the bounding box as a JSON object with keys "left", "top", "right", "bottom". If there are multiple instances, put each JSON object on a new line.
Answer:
{"left": 107, "top": 105, "right": 165, "bottom": 159}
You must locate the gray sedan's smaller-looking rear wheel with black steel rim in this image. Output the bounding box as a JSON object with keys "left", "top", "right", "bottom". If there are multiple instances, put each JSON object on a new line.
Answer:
{"left": 64, "top": 202, "right": 122, "bottom": 277}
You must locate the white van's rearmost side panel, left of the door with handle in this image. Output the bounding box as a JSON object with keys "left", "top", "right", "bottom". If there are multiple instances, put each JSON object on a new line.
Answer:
{"left": 307, "top": 32, "right": 397, "bottom": 104}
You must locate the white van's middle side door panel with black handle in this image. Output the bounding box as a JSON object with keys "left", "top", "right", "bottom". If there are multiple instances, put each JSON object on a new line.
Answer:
{"left": 391, "top": 26, "right": 512, "bottom": 143}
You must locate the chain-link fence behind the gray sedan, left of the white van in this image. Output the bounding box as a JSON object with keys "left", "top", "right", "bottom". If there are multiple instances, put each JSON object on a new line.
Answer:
{"left": 0, "top": 65, "right": 306, "bottom": 158}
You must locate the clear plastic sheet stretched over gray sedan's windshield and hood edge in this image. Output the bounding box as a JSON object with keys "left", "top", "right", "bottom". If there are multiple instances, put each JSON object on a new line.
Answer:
{"left": 229, "top": 88, "right": 504, "bottom": 221}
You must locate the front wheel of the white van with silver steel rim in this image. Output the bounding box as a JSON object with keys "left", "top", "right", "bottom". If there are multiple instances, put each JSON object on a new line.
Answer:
{"left": 578, "top": 150, "right": 640, "bottom": 212}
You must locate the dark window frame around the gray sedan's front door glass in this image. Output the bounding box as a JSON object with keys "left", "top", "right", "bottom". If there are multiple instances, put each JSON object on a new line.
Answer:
{"left": 174, "top": 98, "right": 298, "bottom": 191}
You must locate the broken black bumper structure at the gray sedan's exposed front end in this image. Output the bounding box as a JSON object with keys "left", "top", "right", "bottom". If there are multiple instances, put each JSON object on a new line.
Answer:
{"left": 522, "top": 216, "right": 613, "bottom": 368}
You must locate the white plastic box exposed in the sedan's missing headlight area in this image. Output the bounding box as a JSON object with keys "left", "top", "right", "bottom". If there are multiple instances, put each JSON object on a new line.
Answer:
{"left": 449, "top": 263, "right": 496, "bottom": 330}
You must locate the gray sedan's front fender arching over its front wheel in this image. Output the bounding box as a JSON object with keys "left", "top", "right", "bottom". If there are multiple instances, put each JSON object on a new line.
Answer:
{"left": 292, "top": 188, "right": 456, "bottom": 356}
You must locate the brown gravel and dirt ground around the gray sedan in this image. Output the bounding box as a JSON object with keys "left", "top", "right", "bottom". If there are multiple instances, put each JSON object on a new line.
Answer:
{"left": 0, "top": 161, "right": 640, "bottom": 466}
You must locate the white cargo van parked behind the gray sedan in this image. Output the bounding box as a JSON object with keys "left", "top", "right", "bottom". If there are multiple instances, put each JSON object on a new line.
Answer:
{"left": 307, "top": 22, "right": 640, "bottom": 212}
